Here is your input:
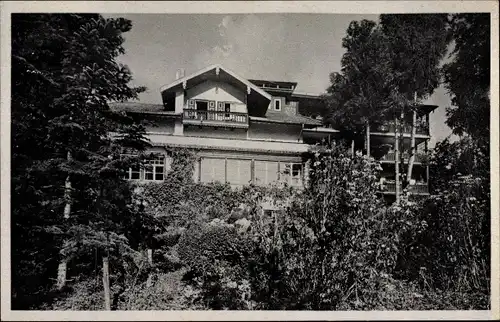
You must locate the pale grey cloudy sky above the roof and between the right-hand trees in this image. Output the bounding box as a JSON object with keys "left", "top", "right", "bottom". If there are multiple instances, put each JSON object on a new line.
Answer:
{"left": 104, "top": 13, "right": 458, "bottom": 147}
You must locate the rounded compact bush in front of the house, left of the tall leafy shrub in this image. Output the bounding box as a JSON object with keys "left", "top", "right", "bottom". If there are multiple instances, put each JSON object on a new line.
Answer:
{"left": 178, "top": 219, "right": 251, "bottom": 310}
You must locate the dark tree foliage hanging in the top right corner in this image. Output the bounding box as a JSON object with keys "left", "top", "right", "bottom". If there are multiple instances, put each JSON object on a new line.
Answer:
{"left": 443, "top": 13, "right": 490, "bottom": 144}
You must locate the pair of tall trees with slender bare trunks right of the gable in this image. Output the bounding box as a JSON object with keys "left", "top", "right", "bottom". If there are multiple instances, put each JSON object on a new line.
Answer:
{"left": 327, "top": 14, "right": 448, "bottom": 199}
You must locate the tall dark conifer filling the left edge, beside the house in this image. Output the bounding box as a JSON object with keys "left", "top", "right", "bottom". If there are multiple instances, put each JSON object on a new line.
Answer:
{"left": 12, "top": 14, "right": 152, "bottom": 308}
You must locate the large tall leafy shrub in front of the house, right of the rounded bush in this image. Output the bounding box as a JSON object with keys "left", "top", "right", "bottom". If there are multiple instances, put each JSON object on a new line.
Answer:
{"left": 244, "top": 146, "right": 424, "bottom": 310}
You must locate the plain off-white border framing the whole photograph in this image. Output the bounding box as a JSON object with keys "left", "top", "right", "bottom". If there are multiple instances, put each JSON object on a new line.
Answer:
{"left": 0, "top": 1, "right": 500, "bottom": 321}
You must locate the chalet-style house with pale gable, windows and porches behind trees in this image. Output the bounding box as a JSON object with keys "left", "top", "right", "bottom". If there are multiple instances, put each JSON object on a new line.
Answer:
{"left": 112, "top": 65, "right": 438, "bottom": 194}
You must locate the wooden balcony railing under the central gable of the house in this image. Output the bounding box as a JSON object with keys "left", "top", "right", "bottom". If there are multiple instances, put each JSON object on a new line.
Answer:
{"left": 183, "top": 109, "right": 248, "bottom": 128}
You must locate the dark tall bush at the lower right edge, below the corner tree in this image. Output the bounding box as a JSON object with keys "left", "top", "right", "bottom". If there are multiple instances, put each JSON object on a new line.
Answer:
{"left": 398, "top": 139, "right": 491, "bottom": 302}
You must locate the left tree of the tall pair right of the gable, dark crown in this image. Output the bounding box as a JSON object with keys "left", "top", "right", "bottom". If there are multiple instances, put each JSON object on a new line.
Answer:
{"left": 326, "top": 20, "right": 388, "bottom": 135}
